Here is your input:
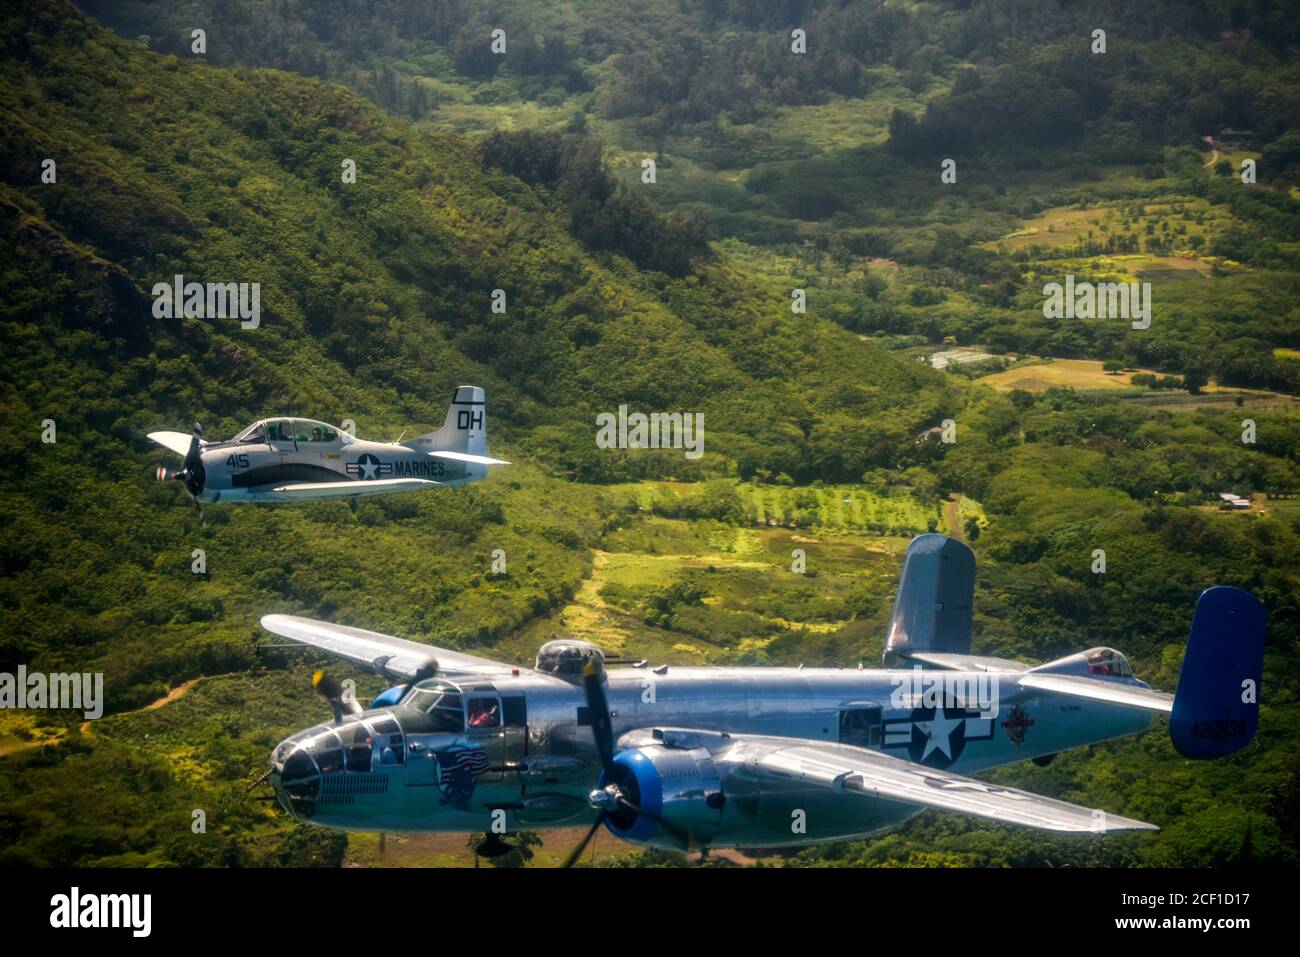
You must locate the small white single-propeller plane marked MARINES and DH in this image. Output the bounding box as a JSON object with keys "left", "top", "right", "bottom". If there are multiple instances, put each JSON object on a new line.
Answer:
{"left": 150, "top": 385, "right": 510, "bottom": 506}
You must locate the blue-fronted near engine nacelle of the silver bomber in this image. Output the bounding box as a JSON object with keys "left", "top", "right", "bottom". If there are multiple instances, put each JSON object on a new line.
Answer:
{"left": 599, "top": 744, "right": 725, "bottom": 850}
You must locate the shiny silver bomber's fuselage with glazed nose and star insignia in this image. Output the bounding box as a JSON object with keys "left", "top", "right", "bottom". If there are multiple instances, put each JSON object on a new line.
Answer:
{"left": 263, "top": 667, "right": 1151, "bottom": 846}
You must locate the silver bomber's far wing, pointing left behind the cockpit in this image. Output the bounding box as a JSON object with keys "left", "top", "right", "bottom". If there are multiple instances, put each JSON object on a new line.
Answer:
{"left": 261, "top": 615, "right": 515, "bottom": 680}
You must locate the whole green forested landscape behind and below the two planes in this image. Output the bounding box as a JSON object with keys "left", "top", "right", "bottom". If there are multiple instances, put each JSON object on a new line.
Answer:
{"left": 0, "top": 0, "right": 1300, "bottom": 865}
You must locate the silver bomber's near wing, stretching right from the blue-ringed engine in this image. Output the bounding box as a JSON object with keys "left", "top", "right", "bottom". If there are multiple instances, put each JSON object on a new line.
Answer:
{"left": 716, "top": 735, "right": 1160, "bottom": 832}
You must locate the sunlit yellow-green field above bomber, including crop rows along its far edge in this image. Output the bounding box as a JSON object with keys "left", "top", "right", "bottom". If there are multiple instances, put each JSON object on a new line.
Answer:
{"left": 493, "top": 482, "right": 967, "bottom": 664}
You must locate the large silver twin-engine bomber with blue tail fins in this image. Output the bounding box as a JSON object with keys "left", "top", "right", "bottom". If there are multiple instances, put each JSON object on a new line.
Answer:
{"left": 261, "top": 534, "right": 1265, "bottom": 862}
